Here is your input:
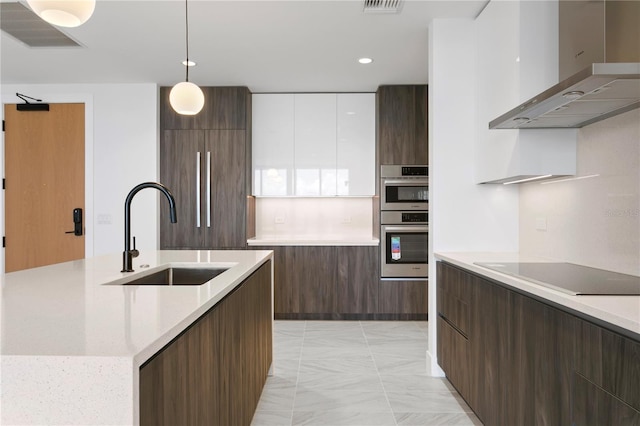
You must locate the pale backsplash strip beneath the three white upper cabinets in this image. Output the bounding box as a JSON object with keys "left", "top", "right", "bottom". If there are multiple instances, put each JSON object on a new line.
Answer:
{"left": 256, "top": 197, "right": 373, "bottom": 240}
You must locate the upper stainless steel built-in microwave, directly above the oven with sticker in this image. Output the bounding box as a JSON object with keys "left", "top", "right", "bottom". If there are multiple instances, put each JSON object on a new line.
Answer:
{"left": 380, "top": 165, "right": 429, "bottom": 211}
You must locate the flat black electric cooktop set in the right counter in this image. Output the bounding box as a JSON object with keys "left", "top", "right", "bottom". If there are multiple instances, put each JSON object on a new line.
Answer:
{"left": 475, "top": 262, "right": 640, "bottom": 296}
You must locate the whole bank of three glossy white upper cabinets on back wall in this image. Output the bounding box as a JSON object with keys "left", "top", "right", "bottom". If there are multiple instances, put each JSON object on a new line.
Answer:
{"left": 252, "top": 93, "right": 375, "bottom": 197}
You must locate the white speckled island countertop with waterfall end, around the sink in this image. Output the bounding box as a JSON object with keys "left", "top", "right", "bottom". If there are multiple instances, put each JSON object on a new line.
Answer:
{"left": 0, "top": 250, "right": 273, "bottom": 425}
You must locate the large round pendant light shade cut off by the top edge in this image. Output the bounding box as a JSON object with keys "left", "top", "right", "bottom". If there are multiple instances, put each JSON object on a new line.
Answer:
{"left": 27, "top": 0, "right": 96, "bottom": 27}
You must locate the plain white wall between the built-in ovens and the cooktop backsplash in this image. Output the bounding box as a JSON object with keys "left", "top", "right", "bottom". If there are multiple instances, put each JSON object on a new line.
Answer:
{"left": 429, "top": 16, "right": 518, "bottom": 375}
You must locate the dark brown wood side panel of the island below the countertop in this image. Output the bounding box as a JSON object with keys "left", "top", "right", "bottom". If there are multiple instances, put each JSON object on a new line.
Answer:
{"left": 140, "top": 262, "right": 272, "bottom": 426}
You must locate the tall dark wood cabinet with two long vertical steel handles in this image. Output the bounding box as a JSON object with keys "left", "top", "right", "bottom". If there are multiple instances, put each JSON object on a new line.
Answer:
{"left": 160, "top": 87, "right": 253, "bottom": 249}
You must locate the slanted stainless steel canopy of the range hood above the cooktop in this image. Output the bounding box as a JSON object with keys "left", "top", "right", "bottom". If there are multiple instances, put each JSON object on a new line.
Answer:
{"left": 489, "top": 62, "right": 640, "bottom": 129}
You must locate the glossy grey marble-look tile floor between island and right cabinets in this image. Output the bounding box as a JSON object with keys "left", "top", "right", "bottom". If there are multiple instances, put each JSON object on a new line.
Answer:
{"left": 252, "top": 321, "right": 482, "bottom": 426}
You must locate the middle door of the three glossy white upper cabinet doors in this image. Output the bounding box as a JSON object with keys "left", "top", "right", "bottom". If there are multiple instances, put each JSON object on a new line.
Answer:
{"left": 294, "top": 93, "right": 336, "bottom": 197}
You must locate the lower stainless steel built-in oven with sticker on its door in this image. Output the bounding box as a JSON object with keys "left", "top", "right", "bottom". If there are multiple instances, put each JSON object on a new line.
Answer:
{"left": 380, "top": 211, "right": 429, "bottom": 278}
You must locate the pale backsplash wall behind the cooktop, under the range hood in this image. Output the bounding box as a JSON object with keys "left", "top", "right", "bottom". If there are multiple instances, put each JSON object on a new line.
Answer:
{"left": 519, "top": 109, "right": 640, "bottom": 275}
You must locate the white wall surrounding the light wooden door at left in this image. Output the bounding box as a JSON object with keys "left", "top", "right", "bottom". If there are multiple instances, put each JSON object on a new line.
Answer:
{"left": 0, "top": 84, "right": 159, "bottom": 266}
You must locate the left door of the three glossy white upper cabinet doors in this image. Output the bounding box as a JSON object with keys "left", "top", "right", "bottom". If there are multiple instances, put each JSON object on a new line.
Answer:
{"left": 252, "top": 94, "right": 295, "bottom": 196}
